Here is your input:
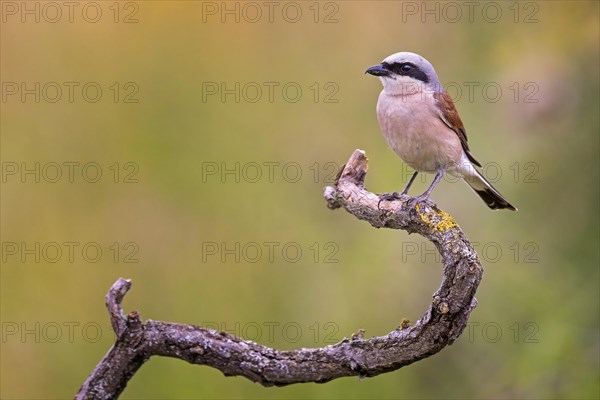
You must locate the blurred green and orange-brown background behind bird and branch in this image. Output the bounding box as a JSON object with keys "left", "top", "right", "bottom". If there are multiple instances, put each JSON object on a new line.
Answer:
{"left": 0, "top": 1, "right": 600, "bottom": 399}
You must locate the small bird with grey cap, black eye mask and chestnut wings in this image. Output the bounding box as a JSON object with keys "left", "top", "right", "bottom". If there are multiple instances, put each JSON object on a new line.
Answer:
{"left": 365, "top": 52, "right": 517, "bottom": 211}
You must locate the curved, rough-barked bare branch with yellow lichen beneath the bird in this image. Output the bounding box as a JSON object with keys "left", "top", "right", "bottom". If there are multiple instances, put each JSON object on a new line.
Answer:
{"left": 77, "top": 150, "right": 483, "bottom": 399}
